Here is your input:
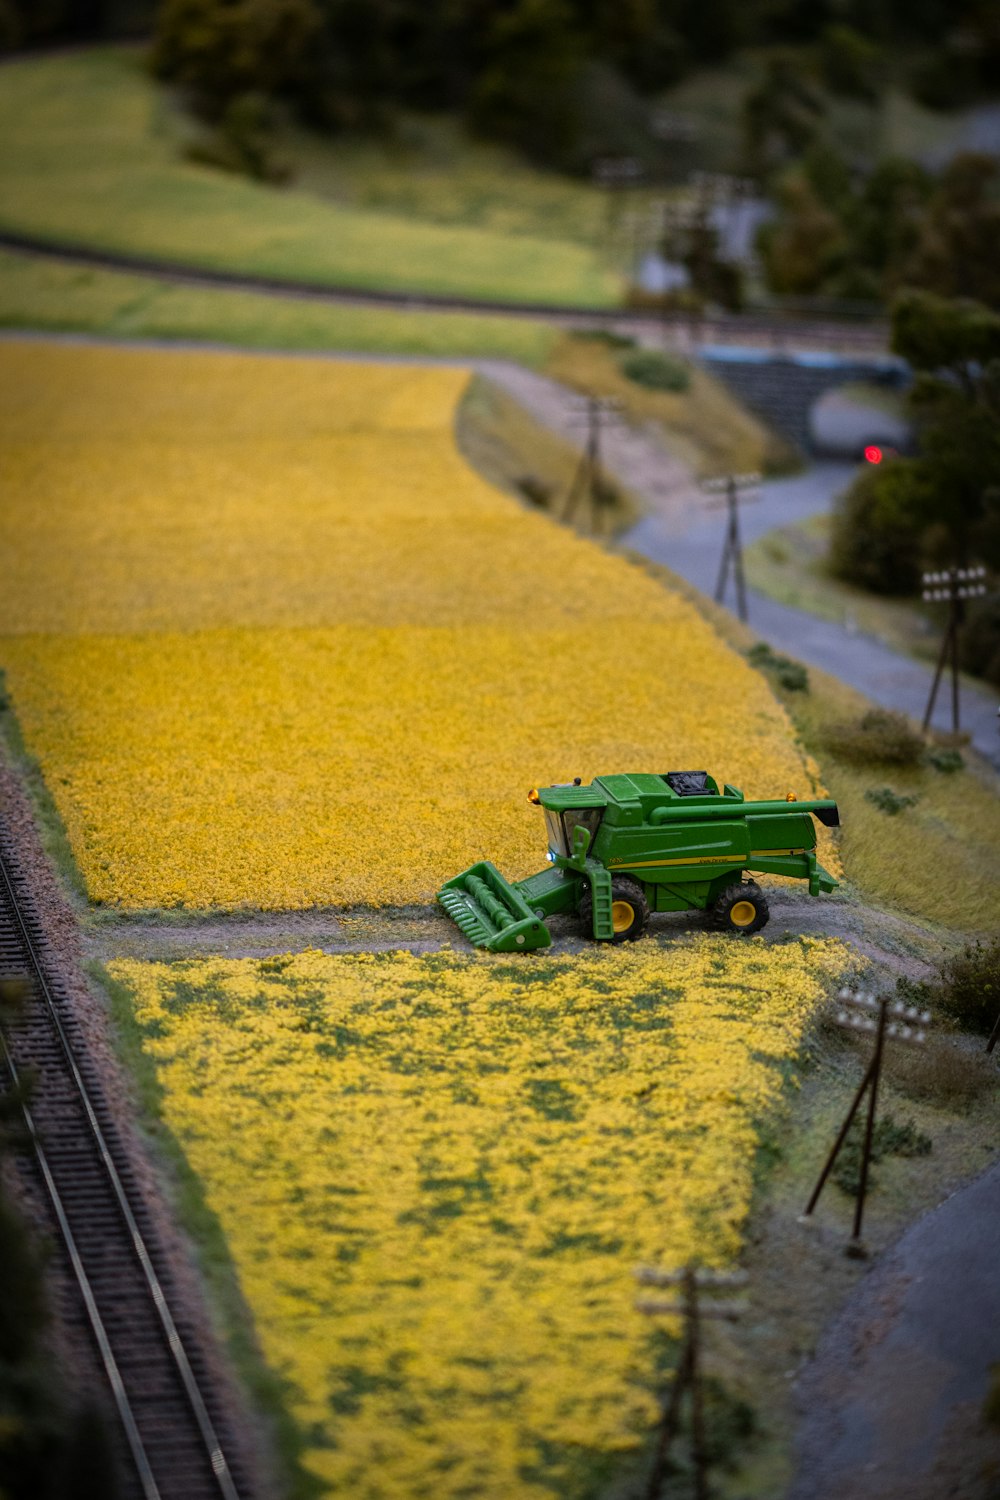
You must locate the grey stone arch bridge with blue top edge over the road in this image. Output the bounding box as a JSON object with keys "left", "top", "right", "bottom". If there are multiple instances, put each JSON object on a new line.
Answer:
{"left": 697, "top": 345, "right": 909, "bottom": 453}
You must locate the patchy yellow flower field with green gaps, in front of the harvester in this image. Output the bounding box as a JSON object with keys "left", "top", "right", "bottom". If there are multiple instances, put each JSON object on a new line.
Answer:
{"left": 111, "top": 936, "right": 847, "bottom": 1500}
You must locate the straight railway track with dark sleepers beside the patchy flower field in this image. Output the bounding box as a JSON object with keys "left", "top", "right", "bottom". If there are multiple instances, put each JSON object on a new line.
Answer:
{"left": 0, "top": 831, "right": 250, "bottom": 1500}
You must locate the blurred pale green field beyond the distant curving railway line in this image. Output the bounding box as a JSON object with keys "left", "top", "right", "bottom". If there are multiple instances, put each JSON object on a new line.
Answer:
{"left": 0, "top": 48, "right": 618, "bottom": 306}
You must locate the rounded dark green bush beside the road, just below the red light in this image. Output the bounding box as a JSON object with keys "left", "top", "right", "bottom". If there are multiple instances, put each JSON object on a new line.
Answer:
{"left": 831, "top": 459, "right": 928, "bottom": 594}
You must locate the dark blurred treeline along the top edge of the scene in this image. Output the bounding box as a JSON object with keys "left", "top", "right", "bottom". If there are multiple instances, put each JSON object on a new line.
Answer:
{"left": 144, "top": 0, "right": 996, "bottom": 170}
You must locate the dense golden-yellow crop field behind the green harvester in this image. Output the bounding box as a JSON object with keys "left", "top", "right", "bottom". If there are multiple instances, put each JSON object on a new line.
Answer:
{"left": 0, "top": 341, "right": 835, "bottom": 909}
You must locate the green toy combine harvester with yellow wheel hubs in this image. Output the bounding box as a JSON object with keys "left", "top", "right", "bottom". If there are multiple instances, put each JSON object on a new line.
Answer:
{"left": 438, "top": 771, "right": 840, "bottom": 953}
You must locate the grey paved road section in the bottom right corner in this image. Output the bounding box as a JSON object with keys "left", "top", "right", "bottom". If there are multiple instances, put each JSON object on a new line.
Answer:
{"left": 789, "top": 1164, "right": 1000, "bottom": 1500}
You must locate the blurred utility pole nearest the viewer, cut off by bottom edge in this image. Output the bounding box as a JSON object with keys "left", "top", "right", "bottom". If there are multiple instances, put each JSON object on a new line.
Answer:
{"left": 636, "top": 1266, "right": 747, "bottom": 1500}
